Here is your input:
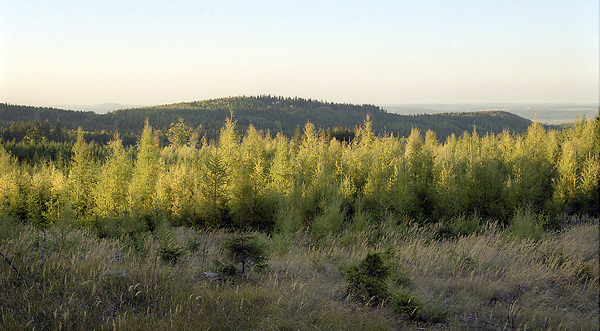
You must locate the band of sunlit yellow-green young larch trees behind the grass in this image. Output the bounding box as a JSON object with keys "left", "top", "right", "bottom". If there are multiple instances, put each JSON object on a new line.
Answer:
{"left": 0, "top": 113, "right": 600, "bottom": 234}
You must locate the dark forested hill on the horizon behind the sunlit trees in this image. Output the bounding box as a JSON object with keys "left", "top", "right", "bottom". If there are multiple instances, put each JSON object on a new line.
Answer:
{"left": 0, "top": 96, "right": 531, "bottom": 140}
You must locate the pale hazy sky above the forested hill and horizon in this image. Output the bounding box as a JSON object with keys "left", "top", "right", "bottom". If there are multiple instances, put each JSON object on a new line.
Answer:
{"left": 0, "top": 0, "right": 600, "bottom": 106}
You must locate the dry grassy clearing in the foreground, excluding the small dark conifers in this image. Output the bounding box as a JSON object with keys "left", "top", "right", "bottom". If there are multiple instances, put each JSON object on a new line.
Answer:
{"left": 0, "top": 219, "right": 600, "bottom": 330}
